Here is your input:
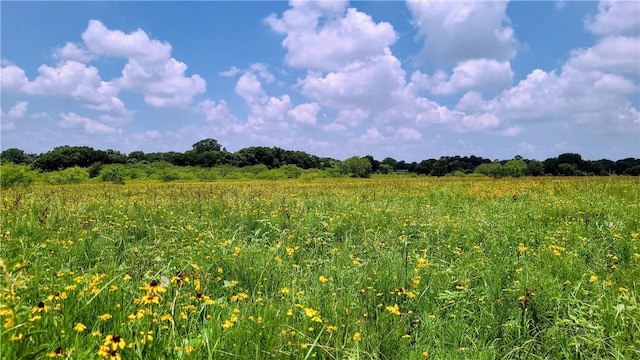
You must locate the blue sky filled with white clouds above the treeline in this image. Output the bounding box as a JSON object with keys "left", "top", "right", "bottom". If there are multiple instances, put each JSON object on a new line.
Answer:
{"left": 0, "top": 1, "right": 640, "bottom": 161}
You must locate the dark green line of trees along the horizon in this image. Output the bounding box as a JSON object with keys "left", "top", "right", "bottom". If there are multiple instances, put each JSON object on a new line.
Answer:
{"left": 0, "top": 139, "right": 640, "bottom": 178}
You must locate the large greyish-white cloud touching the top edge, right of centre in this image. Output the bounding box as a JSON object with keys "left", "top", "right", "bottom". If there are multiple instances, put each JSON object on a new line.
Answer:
{"left": 407, "top": 1, "right": 518, "bottom": 66}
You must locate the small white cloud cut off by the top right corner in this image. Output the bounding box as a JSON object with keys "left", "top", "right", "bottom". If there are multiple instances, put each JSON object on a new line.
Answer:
{"left": 585, "top": 1, "right": 640, "bottom": 36}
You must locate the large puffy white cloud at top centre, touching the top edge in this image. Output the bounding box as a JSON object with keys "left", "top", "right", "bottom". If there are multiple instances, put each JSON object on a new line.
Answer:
{"left": 266, "top": 1, "right": 398, "bottom": 71}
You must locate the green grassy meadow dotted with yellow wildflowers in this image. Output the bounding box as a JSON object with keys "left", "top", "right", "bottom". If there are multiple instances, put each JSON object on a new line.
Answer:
{"left": 0, "top": 177, "right": 640, "bottom": 359}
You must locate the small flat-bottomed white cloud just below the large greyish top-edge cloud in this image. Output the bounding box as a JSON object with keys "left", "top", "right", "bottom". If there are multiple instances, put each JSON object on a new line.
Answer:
{"left": 431, "top": 59, "right": 513, "bottom": 94}
